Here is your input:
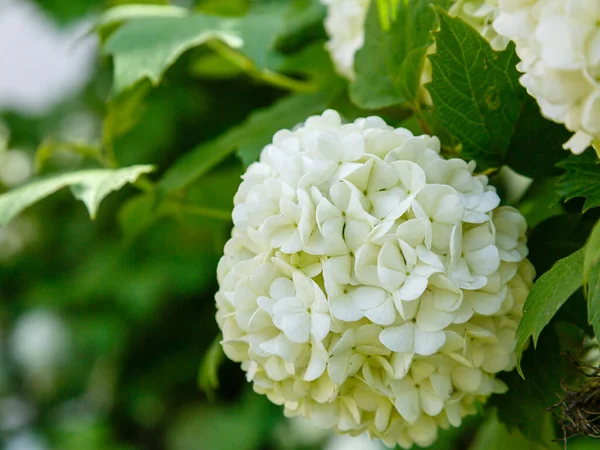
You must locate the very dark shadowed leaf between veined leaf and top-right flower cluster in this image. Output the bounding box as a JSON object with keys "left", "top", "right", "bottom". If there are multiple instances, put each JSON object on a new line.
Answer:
{"left": 506, "top": 96, "right": 571, "bottom": 179}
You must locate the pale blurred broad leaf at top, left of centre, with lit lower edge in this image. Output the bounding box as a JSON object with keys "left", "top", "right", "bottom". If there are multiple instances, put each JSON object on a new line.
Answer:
{"left": 105, "top": 5, "right": 284, "bottom": 93}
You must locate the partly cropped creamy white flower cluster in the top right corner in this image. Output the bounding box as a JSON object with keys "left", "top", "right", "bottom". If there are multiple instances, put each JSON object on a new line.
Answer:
{"left": 494, "top": 0, "right": 600, "bottom": 154}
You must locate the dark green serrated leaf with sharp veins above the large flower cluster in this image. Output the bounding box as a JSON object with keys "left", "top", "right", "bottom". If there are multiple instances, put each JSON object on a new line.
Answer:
{"left": 426, "top": 8, "right": 524, "bottom": 169}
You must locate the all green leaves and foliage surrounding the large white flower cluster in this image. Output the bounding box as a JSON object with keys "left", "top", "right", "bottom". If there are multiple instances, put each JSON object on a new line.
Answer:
{"left": 7, "top": 0, "right": 600, "bottom": 450}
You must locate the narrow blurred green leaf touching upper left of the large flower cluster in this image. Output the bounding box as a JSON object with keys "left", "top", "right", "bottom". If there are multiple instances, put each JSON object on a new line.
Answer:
{"left": 159, "top": 89, "right": 338, "bottom": 193}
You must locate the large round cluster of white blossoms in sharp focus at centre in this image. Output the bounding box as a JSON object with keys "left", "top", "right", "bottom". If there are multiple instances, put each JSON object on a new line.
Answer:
{"left": 216, "top": 110, "right": 534, "bottom": 448}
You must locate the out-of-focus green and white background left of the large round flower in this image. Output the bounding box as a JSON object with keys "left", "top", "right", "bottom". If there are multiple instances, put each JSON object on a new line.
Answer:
{"left": 0, "top": 0, "right": 597, "bottom": 450}
